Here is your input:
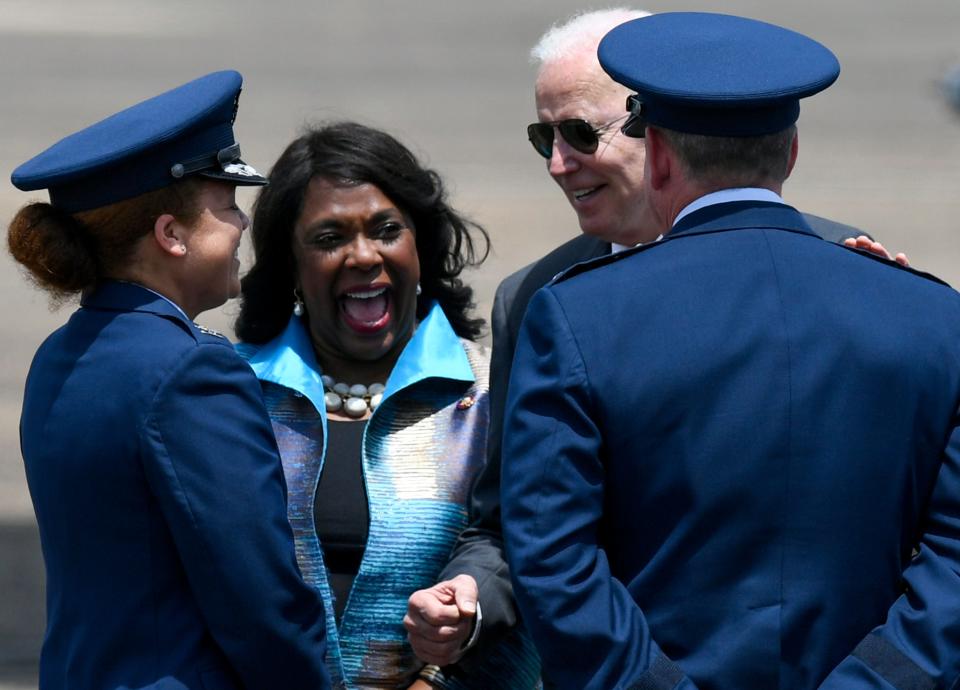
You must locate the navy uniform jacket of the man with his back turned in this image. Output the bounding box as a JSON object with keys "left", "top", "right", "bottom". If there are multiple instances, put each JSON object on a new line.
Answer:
{"left": 502, "top": 202, "right": 960, "bottom": 690}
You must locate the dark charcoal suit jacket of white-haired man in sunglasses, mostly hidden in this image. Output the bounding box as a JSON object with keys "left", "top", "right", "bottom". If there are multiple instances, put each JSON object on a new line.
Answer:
{"left": 440, "top": 213, "right": 867, "bottom": 668}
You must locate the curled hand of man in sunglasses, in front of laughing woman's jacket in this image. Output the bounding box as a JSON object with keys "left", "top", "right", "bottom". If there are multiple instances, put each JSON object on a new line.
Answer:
{"left": 403, "top": 575, "right": 478, "bottom": 666}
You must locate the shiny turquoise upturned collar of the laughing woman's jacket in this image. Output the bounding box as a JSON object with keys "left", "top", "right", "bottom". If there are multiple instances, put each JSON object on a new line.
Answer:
{"left": 239, "top": 303, "right": 475, "bottom": 410}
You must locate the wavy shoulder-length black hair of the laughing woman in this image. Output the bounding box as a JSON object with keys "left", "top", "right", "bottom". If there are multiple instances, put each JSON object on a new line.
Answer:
{"left": 234, "top": 122, "right": 490, "bottom": 343}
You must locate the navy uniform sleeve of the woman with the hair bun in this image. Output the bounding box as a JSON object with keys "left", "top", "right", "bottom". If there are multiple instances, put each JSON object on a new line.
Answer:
{"left": 141, "top": 344, "right": 330, "bottom": 690}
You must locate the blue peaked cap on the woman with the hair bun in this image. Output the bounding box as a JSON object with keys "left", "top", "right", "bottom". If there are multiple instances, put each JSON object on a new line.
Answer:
{"left": 11, "top": 70, "right": 267, "bottom": 213}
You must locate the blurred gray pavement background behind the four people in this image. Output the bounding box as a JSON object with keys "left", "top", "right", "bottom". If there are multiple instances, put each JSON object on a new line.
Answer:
{"left": 0, "top": 0, "right": 960, "bottom": 690}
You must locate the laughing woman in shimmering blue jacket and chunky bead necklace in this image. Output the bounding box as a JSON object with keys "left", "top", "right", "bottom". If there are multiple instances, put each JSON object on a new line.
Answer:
{"left": 236, "top": 122, "right": 538, "bottom": 690}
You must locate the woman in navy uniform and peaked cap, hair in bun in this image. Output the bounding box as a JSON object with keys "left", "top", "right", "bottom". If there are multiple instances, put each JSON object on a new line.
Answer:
{"left": 8, "top": 71, "right": 329, "bottom": 690}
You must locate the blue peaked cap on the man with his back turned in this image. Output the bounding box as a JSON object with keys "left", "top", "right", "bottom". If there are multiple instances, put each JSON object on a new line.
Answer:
{"left": 597, "top": 12, "right": 840, "bottom": 137}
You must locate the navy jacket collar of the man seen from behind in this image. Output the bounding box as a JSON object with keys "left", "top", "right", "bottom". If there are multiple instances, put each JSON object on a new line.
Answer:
{"left": 665, "top": 201, "right": 818, "bottom": 239}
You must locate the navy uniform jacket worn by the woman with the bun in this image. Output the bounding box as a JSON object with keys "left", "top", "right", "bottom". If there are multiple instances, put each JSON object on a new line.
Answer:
{"left": 20, "top": 283, "right": 329, "bottom": 690}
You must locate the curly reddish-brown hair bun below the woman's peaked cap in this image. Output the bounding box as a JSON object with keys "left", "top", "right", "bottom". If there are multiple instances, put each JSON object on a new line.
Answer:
{"left": 7, "top": 202, "right": 98, "bottom": 303}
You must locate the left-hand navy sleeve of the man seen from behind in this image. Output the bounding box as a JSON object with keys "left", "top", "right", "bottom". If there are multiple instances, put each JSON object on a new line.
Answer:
{"left": 501, "top": 289, "right": 695, "bottom": 690}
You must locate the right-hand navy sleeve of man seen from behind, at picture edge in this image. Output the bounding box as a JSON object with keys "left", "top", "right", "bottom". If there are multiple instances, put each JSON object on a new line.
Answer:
{"left": 820, "top": 406, "right": 960, "bottom": 690}
